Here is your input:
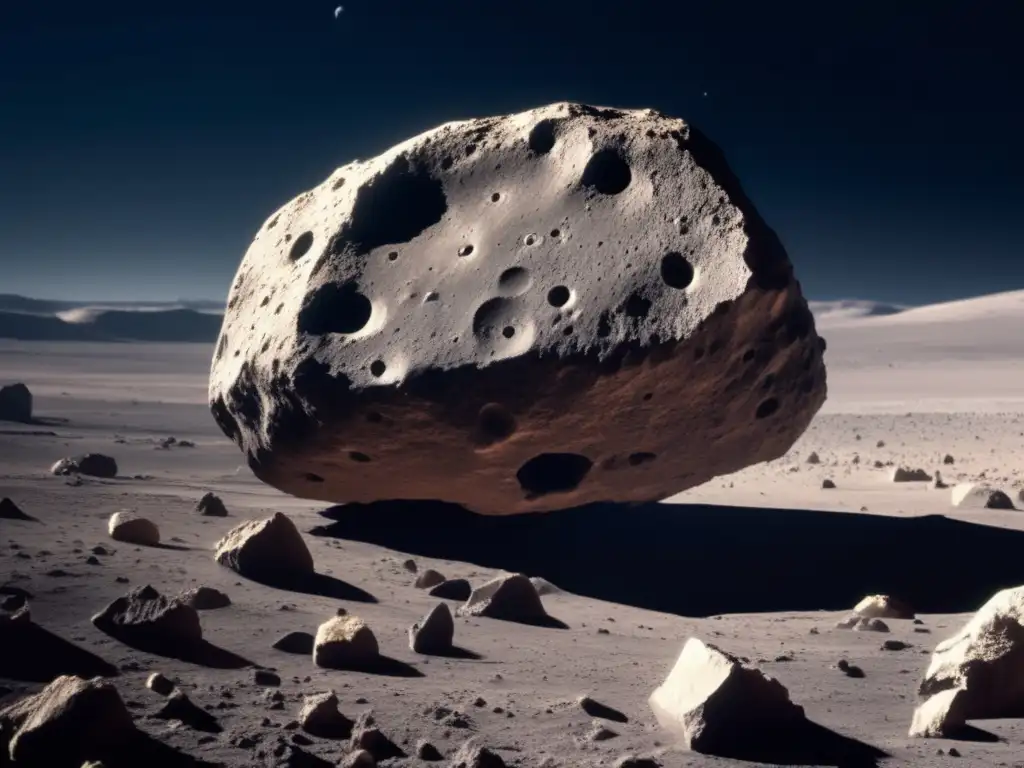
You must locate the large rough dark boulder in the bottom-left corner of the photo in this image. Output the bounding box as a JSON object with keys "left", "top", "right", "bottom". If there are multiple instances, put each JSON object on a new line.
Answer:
{"left": 0, "top": 675, "right": 136, "bottom": 768}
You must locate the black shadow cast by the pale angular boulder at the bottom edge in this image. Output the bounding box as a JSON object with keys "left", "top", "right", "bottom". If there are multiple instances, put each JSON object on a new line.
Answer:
{"left": 714, "top": 720, "right": 889, "bottom": 768}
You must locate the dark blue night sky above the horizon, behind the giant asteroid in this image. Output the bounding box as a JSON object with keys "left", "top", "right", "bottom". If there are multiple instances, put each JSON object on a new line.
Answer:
{"left": 0, "top": 0, "right": 1024, "bottom": 303}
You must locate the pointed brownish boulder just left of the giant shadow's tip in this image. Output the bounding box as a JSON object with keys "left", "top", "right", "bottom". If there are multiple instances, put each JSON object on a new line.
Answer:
{"left": 215, "top": 512, "right": 313, "bottom": 580}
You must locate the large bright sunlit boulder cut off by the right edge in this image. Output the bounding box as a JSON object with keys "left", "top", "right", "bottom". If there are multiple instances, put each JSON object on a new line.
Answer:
{"left": 910, "top": 587, "right": 1024, "bottom": 737}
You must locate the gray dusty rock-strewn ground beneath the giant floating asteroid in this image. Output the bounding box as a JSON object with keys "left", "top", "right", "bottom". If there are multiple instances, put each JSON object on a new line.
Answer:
{"left": 0, "top": 343, "right": 1024, "bottom": 767}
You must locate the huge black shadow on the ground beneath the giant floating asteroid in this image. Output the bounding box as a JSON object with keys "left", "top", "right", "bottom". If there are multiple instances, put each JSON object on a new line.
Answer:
{"left": 310, "top": 501, "right": 1024, "bottom": 616}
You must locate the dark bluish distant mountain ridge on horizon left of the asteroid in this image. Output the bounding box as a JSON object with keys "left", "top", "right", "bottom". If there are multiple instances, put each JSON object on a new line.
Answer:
{"left": 0, "top": 294, "right": 223, "bottom": 344}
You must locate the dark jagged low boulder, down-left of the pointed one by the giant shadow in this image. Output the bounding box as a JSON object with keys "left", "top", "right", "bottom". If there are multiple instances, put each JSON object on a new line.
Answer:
{"left": 92, "top": 585, "right": 203, "bottom": 648}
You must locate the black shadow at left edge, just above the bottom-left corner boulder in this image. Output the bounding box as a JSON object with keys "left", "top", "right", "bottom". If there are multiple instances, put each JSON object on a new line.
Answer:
{"left": 0, "top": 623, "right": 118, "bottom": 683}
